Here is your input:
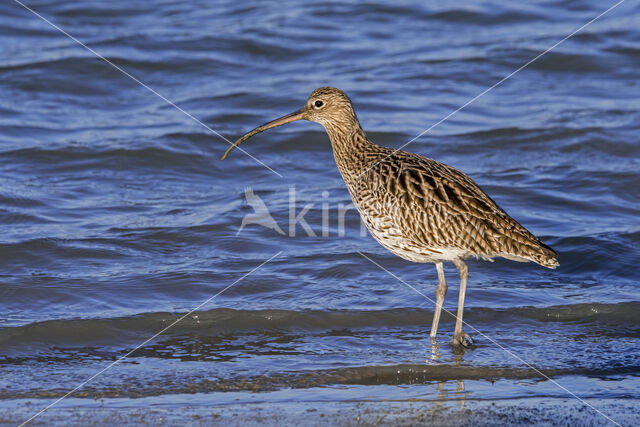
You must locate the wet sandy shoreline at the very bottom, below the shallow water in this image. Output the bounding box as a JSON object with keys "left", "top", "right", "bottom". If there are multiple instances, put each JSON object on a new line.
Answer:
{"left": 0, "top": 390, "right": 640, "bottom": 426}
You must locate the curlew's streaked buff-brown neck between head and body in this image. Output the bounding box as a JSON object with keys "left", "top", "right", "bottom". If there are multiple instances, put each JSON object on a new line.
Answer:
{"left": 324, "top": 119, "right": 373, "bottom": 182}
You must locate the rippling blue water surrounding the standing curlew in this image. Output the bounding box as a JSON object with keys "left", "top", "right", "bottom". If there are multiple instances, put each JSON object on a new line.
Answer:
{"left": 0, "top": 1, "right": 640, "bottom": 423}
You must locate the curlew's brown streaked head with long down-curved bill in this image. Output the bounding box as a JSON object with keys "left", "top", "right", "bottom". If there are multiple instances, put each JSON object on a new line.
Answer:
{"left": 222, "top": 87, "right": 358, "bottom": 160}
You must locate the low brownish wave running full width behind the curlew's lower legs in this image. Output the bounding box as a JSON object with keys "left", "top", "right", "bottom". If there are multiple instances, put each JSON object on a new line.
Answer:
{"left": 0, "top": 302, "right": 640, "bottom": 352}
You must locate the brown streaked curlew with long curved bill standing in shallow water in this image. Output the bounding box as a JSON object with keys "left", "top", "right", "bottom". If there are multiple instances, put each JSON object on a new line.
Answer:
{"left": 222, "top": 87, "right": 559, "bottom": 347}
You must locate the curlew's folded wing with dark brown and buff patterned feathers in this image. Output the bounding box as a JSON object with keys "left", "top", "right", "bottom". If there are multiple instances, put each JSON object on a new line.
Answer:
{"left": 356, "top": 151, "right": 555, "bottom": 262}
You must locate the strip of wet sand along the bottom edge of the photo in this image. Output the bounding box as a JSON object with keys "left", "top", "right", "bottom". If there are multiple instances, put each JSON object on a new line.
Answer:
{"left": 0, "top": 398, "right": 640, "bottom": 426}
